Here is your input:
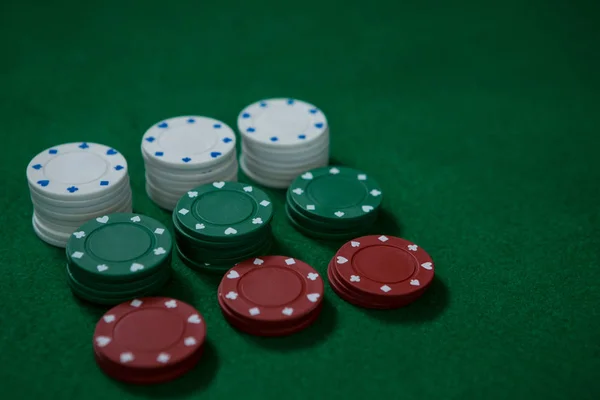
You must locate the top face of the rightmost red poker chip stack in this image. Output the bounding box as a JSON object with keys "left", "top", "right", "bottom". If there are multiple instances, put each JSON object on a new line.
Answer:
{"left": 333, "top": 235, "right": 434, "bottom": 296}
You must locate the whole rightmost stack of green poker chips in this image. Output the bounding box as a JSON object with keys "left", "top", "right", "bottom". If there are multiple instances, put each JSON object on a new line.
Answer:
{"left": 285, "top": 167, "right": 382, "bottom": 240}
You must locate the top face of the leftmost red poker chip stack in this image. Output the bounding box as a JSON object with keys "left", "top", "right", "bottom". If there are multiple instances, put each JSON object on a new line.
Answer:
{"left": 94, "top": 297, "right": 206, "bottom": 368}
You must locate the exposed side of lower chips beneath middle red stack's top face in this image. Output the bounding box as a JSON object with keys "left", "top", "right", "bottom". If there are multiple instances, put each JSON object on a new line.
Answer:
{"left": 218, "top": 290, "right": 322, "bottom": 336}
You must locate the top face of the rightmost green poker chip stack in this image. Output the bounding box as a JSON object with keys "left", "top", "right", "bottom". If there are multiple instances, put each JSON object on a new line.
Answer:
{"left": 289, "top": 167, "right": 382, "bottom": 220}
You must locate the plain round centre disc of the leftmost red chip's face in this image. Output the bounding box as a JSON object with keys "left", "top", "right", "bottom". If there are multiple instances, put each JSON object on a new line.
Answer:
{"left": 114, "top": 308, "right": 185, "bottom": 351}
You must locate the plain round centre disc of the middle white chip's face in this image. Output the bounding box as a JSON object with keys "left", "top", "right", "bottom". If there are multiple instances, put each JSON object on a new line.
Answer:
{"left": 158, "top": 125, "right": 219, "bottom": 154}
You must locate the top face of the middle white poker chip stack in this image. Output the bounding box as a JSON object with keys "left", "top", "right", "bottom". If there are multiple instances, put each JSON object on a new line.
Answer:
{"left": 142, "top": 116, "right": 235, "bottom": 168}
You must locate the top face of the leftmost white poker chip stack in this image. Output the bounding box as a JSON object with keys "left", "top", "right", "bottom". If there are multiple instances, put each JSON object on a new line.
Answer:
{"left": 27, "top": 142, "right": 127, "bottom": 199}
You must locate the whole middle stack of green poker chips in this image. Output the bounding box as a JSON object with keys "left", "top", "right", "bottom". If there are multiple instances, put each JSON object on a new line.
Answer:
{"left": 173, "top": 182, "right": 273, "bottom": 274}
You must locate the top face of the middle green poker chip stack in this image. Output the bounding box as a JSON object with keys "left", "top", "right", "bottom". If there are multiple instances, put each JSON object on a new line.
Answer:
{"left": 173, "top": 182, "right": 273, "bottom": 239}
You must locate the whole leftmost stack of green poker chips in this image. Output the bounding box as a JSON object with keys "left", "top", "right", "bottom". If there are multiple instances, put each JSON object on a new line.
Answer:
{"left": 66, "top": 213, "right": 173, "bottom": 305}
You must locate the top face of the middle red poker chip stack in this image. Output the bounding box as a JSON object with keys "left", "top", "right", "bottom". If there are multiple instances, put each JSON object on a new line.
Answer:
{"left": 219, "top": 256, "right": 323, "bottom": 321}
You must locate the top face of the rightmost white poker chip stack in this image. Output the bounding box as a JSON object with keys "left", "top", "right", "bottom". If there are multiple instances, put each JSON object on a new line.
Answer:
{"left": 238, "top": 99, "right": 328, "bottom": 146}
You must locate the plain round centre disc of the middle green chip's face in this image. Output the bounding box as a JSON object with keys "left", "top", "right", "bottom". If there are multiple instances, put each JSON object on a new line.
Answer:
{"left": 194, "top": 190, "right": 254, "bottom": 225}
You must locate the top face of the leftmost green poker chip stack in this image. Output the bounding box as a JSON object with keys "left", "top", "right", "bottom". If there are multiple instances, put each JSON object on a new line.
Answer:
{"left": 66, "top": 213, "right": 173, "bottom": 279}
